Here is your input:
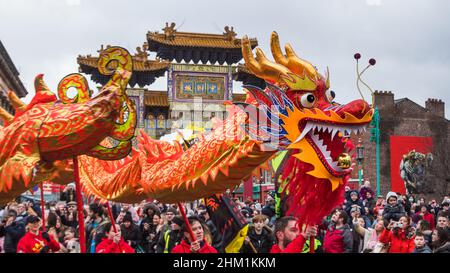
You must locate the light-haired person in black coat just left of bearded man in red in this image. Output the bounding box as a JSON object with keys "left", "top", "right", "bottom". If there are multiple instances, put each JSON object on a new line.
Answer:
{"left": 241, "top": 214, "right": 275, "bottom": 253}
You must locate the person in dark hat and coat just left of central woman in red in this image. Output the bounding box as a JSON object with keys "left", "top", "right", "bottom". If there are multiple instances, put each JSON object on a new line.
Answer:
{"left": 156, "top": 214, "right": 184, "bottom": 253}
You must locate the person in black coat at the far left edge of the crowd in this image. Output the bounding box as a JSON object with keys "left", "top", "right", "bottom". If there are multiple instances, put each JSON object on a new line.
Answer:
{"left": 0, "top": 209, "right": 26, "bottom": 253}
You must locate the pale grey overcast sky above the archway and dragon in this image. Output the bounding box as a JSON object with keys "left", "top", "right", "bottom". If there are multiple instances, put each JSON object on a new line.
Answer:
{"left": 0, "top": 0, "right": 450, "bottom": 118}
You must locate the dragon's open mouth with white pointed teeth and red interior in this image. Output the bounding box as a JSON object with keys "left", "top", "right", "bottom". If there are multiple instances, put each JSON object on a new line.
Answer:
{"left": 297, "top": 121, "right": 367, "bottom": 177}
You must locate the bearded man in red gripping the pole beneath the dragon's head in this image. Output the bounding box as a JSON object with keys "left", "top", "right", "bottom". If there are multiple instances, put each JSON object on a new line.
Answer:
{"left": 270, "top": 216, "right": 317, "bottom": 253}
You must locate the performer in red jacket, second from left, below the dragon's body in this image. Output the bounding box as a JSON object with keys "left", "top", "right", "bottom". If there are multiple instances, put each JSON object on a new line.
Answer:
{"left": 95, "top": 223, "right": 135, "bottom": 253}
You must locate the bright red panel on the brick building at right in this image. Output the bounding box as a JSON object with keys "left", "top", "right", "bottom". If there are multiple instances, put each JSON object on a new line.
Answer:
{"left": 390, "top": 136, "right": 433, "bottom": 194}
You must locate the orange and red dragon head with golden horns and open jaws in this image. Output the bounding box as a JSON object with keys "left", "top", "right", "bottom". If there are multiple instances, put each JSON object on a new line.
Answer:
{"left": 242, "top": 32, "right": 374, "bottom": 191}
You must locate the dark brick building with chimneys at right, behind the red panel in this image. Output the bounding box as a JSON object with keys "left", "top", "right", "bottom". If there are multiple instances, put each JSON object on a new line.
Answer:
{"left": 353, "top": 91, "right": 450, "bottom": 200}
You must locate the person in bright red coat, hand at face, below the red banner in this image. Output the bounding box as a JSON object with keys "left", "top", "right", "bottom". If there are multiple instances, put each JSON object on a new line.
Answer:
{"left": 378, "top": 216, "right": 415, "bottom": 253}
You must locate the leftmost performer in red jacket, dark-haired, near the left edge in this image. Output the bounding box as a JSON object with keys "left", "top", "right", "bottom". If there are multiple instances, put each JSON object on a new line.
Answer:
{"left": 17, "top": 215, "right": 60, "bottom": 253}
